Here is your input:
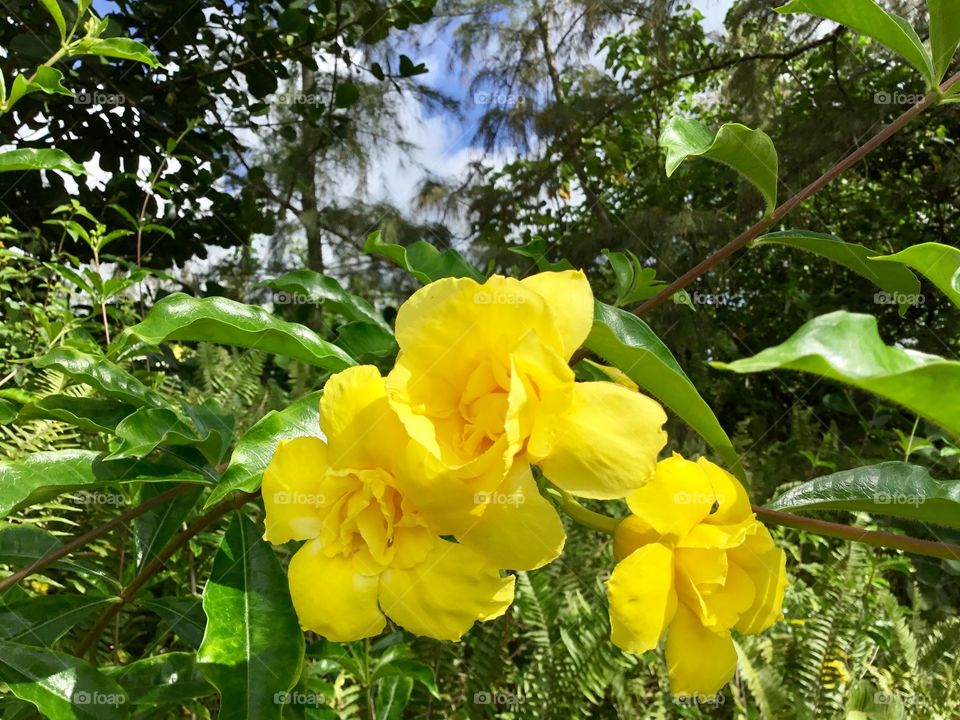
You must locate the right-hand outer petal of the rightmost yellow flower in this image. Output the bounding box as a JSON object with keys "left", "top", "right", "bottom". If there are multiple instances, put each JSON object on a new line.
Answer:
{"left": 730, "top": 522, "right": 787, "bottom": 635}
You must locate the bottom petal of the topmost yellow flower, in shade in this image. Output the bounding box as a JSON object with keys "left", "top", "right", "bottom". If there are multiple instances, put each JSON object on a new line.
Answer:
{"left": 457, "top": 462, "right": 566, "bottom": 570}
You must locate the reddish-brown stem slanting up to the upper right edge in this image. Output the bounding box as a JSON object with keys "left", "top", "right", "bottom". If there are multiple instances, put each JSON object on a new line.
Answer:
{"left": 630, "top": 72, "right": 960, "bottom": 316}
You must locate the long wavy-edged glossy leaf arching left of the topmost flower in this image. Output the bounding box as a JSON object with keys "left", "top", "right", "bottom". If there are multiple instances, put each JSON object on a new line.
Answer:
{"left": 119, "top": 293, "right": 356, "bottom": 371}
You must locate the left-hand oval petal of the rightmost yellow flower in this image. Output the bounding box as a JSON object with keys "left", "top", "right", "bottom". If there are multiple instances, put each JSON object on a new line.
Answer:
{"left": 607, "top": 543, "right": 677, "bottom": 654}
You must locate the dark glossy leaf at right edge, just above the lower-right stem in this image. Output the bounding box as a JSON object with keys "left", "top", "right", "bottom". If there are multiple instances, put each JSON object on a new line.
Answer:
{"left": 769, "top": 462, "right": 960, "bottom": 528}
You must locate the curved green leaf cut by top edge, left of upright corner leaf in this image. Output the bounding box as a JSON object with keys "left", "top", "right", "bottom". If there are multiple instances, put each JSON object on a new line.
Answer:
{"left": 777, "top": 0, "right": 937, "bottom": 89}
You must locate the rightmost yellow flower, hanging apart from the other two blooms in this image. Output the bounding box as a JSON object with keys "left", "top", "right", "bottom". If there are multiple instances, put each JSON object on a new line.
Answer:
{"left": 607, "top": 454, "right": 787, "bottom": 695}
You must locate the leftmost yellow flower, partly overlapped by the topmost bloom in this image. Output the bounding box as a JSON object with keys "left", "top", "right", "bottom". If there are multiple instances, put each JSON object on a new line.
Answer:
{"left": 263, "top": 366, "right": 514, "bottom": 642}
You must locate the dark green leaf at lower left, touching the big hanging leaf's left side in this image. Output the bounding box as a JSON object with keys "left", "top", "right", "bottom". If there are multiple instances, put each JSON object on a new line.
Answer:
{"left": 103, "top": 652, "right": 216, "bottom": 706}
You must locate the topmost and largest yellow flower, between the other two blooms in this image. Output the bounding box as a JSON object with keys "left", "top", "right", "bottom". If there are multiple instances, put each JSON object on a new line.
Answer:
{"left": 387, "top": 271, "right": 666, "bottom": 569}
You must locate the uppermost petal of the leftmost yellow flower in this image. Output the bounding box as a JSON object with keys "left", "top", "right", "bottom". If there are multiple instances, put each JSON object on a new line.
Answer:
{"left": 320, "top": 365, "right": 408, "bottom": 470}
